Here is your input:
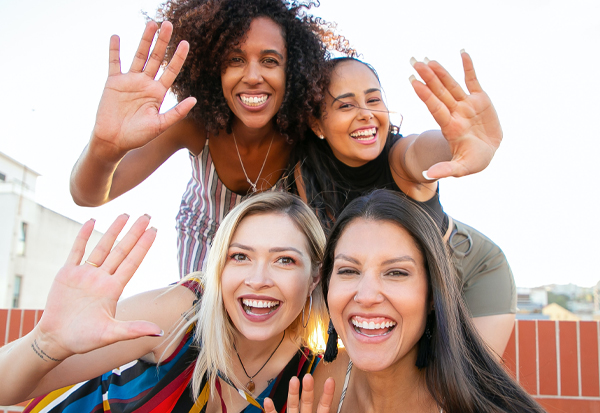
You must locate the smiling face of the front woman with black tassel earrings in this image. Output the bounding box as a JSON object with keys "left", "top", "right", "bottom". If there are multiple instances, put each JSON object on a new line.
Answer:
{"left": 327, "top": 218, "right": 430, "bottom": 371}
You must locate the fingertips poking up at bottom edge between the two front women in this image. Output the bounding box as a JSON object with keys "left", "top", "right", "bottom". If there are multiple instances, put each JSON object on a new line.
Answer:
{"left": 265, "top": 374, "right": 335, "bottom": 413}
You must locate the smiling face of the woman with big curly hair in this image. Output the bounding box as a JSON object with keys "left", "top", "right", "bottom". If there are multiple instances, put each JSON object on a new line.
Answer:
{"left": 221, "top": 17, "right": 287, "bottom": 129}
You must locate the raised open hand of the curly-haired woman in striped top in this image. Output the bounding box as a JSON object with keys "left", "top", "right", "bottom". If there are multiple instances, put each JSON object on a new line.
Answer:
{"left": 90, "top": 22, "right": 196, "bottom": 161}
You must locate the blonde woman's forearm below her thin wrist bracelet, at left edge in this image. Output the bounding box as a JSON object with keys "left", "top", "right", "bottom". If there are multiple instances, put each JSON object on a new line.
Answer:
{"left": 0, "top": 328, "right": 69, "bottom": 406}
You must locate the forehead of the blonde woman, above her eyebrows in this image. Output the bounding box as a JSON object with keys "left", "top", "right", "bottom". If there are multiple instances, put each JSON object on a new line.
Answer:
{"left": 231, "top": 212, "right": 308, "bottom": 251}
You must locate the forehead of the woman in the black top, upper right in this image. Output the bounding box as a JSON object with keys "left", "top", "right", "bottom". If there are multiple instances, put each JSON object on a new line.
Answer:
{"left": 329, "top": 60, "right": 381, "bottom": 96}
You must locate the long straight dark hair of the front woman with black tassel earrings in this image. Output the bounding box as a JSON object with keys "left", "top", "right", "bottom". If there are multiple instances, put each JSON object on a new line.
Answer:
{"left": 321, "top": 189, "right": 544, "bottom": 413}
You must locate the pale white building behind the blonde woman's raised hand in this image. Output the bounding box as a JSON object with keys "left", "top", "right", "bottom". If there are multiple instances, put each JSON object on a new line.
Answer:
{"left": 0, "top": 152, "right": 102, "bottom": 308}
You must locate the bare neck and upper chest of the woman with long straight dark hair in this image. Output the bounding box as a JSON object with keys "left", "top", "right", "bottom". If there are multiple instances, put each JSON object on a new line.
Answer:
{"left": 343, "top": 358, "right": 439, "bottom": 413}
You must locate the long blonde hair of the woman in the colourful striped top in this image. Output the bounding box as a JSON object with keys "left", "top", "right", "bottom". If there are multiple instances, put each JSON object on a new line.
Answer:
{"left": 183, "top": 192, "right": 329, "bottom": 398}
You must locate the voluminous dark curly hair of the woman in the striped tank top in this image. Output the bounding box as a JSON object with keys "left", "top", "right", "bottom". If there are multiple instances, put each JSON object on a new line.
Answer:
{"left": 158, "top": 0, "right": 354, "bottom": 142}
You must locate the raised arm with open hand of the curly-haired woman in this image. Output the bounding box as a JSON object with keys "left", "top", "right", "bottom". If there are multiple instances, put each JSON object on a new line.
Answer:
{"left": 71, "top": 22, "right": 196, "bottom": 206}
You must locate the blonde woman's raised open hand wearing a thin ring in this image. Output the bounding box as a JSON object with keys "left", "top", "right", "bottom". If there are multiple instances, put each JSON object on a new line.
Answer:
{"left": 38, "top": 215, "right": 162, "bottom": 359}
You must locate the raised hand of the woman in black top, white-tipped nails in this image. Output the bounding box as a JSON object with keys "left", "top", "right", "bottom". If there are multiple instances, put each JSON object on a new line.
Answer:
{"left": 411, "top": 51, "right": 502, "bottom": 179}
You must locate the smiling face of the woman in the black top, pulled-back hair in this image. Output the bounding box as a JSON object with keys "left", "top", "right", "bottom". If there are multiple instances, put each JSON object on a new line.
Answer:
{"left": 313, "top": 60, "right": 390, "bottom": 166}
